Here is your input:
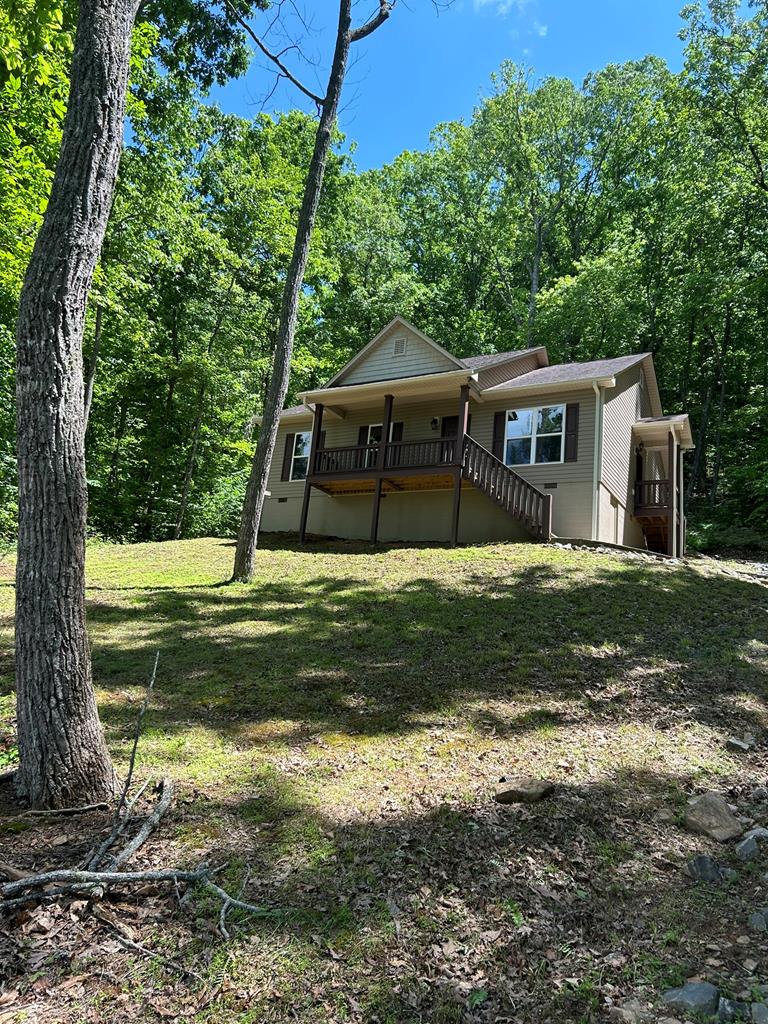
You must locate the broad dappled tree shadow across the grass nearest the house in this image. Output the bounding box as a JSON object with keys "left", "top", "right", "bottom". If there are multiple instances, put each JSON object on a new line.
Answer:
{"left": 88, "top": 562, "right": 768, "bottom": 737}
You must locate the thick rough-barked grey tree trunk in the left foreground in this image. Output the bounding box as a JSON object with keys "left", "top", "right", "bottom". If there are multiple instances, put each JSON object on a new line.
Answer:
{"left": 16, "top": 0, "right": 134, "bottom": 807}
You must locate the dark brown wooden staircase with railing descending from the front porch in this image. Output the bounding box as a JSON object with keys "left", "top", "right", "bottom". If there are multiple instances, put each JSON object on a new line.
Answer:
{"left": 462, "top": 434, "right": 552, "bottom": 541}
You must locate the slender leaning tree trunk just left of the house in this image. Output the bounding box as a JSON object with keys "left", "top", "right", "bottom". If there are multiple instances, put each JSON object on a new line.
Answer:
{"left": 232, "top": 0, "right": 350, "bottom": 582}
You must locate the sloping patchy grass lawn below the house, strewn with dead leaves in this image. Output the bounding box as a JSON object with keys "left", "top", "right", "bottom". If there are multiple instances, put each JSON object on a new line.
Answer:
{"left": 0, "top": 540, "right": 768, "bottom": 1024}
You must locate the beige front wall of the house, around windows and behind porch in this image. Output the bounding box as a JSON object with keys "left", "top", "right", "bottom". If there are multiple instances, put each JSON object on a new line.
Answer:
{"left": 262, "top": 389, "right": 595, "bottom": 541}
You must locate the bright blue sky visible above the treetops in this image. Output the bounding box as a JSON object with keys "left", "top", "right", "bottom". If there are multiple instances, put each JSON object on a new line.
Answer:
{"left": 211, "top": 0, "right": 683, "bottom": 168}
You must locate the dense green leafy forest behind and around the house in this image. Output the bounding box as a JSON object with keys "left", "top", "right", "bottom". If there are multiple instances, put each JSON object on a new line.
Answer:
{"left": 0, "top": 0, "right": 768, "bottom": 546}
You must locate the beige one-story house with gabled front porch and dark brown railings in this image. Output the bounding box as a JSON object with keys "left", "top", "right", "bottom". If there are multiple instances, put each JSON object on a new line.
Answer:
{"left": 261, "top": 316, "right": 693, "bottom": 555}
